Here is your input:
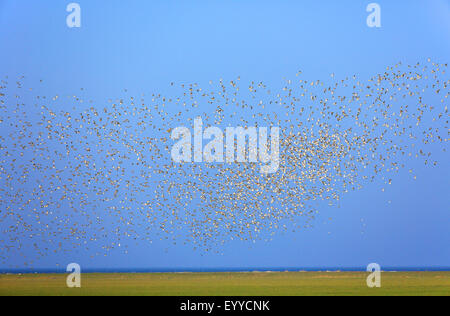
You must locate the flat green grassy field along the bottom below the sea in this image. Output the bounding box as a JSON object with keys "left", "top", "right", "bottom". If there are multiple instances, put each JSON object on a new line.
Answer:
{"left": 0, "top": 272, "right": 450, "bottom": 296}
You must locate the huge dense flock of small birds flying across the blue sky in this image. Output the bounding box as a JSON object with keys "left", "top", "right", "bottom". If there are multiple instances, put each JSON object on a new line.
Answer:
{"left": 0, "top": 60, "right": 450, "bottom": 265}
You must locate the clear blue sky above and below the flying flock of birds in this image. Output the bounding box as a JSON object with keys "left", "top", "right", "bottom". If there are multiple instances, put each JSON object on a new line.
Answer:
{"left": 0, "top": 0, "right": 450, "bottom": 269}
